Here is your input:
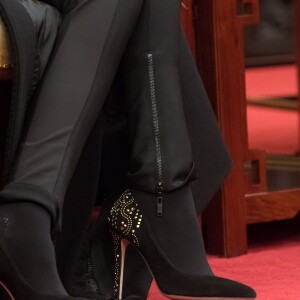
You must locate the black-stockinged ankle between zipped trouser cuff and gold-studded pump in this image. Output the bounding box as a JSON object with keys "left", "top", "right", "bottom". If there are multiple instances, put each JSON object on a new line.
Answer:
{"left": 133, "top": 185, "right": 213, "bottom": 275}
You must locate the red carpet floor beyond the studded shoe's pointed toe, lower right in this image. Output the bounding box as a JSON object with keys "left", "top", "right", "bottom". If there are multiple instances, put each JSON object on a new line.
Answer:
{"left": 210, "top": 221, "right": 300, "bottom": 300}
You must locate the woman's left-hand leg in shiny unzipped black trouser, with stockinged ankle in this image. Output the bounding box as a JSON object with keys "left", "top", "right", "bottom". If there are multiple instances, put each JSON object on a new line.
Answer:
{"left": 0, "top": 0, "right": 141, "bottom": 300}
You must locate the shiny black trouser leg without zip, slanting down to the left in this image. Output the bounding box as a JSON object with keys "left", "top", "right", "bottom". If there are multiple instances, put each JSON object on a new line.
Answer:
{"left": 0, "top": 0, "right": 141, "bottom": 228}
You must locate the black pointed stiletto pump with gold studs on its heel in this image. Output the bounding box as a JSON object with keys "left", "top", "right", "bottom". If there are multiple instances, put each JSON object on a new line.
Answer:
{"left": 108, "top": 190, "right": 256, "bottom": 300}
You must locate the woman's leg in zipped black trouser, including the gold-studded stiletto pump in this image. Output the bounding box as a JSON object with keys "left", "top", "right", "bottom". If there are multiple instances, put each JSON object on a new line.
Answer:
{"left": 109, "top": 0, "right": 255, "bottom": 299}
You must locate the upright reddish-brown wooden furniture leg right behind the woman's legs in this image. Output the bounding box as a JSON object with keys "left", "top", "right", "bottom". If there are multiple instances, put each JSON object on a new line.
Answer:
{"left": 194, "top": 0, "right": 259, "bottom": 257}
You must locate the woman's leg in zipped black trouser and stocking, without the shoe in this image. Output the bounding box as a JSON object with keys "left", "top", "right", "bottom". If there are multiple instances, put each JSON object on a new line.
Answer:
{"left": 118, "top": 0, "right": 212, "bottom": 274}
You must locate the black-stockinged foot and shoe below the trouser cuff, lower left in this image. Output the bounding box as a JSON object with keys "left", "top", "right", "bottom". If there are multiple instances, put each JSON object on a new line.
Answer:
{"left": 0, "top": 202, "right": 88, "bottom": 300}
